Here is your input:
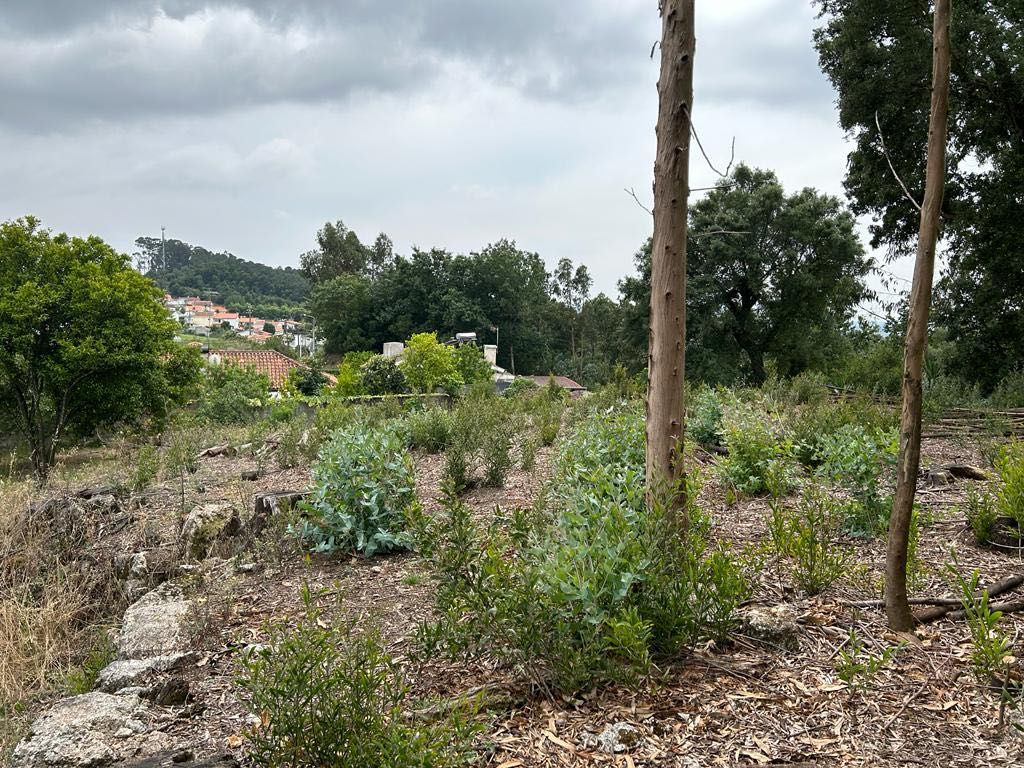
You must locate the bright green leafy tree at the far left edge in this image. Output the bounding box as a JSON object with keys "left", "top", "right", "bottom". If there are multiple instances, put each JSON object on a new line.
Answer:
{"left": 0, "top": 216, "right": 180, "bottom": 480}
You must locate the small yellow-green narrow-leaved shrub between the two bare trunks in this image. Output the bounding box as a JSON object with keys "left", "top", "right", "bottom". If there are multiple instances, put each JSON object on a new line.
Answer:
{"left": 768, "top": 487, "right": 850, "bottom": 595}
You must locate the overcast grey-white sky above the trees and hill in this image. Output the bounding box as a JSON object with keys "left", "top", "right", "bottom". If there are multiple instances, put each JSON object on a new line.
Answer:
{"left": 0, "top": 0, "right": 905, "bottom": 303}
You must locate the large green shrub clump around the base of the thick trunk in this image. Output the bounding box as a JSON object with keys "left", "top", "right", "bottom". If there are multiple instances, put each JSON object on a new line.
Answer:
{"left": 419, "top": 412, "right": 746, "bottom": 691}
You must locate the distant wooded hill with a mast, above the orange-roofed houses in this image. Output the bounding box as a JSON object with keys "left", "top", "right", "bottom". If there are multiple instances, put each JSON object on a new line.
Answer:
{"left": 135, "top": 238, "right": 309, "bottom": 319}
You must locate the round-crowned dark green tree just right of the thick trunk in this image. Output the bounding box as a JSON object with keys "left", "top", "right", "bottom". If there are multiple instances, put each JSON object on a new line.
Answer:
{"left": 687, "top": 165, "right": 871, "bottom": 384}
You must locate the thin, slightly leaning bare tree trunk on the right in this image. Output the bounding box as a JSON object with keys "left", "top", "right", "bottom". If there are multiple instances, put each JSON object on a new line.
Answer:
{"left": 886, "top": 0, "right": 951, "bottom": 631}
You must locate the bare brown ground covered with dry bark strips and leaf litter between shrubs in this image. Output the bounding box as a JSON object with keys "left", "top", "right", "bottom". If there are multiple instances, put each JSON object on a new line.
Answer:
{"left": 8, "top": 440, "right": 1024, "bottom": 768}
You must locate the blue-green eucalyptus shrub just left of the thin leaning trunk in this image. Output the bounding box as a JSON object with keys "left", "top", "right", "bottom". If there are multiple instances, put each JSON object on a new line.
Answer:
{"left": 817, "top": 424, "right": 899, "bottom": 536}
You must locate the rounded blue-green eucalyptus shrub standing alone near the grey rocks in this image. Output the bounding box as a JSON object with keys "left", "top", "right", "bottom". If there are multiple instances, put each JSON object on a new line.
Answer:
{"left": 296, "top": 426, "right": 417, "bottom": 556}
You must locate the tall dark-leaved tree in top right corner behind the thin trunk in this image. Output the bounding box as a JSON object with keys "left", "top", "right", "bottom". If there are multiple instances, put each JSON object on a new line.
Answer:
{"left": 814, "top": 0, "right": 1024, "bottom": 391}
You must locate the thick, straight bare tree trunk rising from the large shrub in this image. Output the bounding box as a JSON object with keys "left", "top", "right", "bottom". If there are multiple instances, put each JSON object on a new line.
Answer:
{"left": 646, "top": 0, "right": 695, "bottom": 527}
